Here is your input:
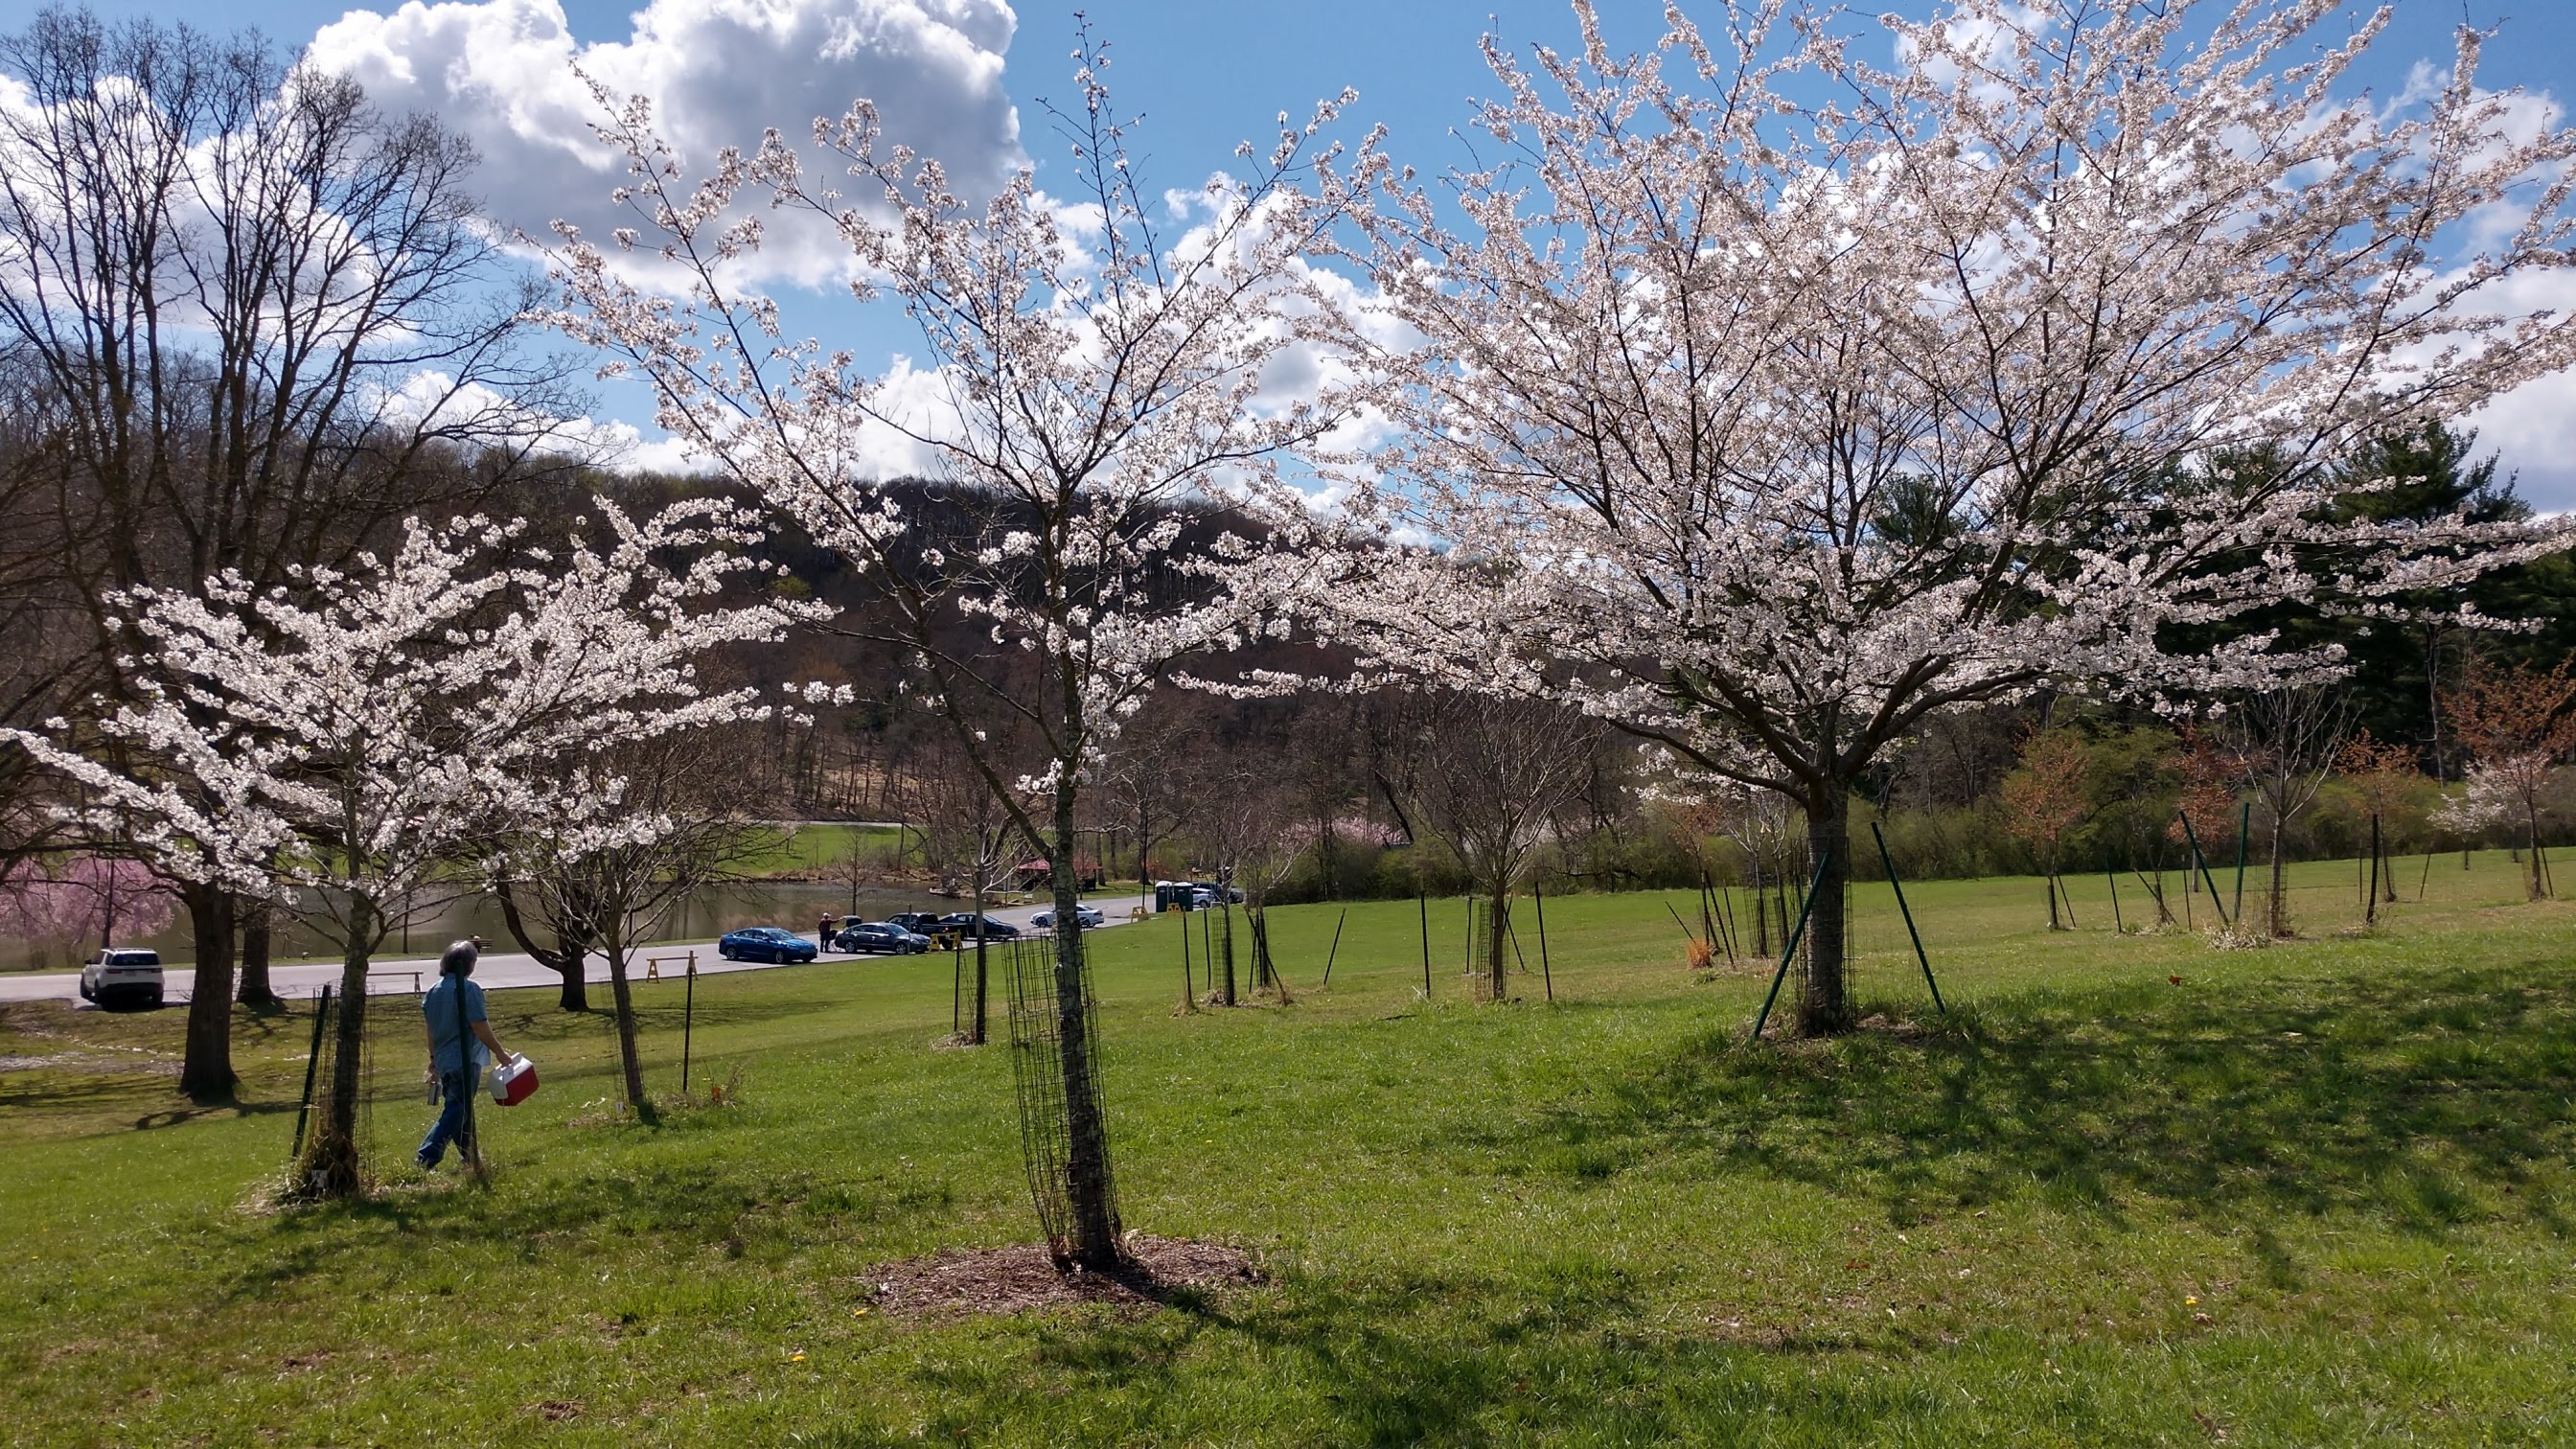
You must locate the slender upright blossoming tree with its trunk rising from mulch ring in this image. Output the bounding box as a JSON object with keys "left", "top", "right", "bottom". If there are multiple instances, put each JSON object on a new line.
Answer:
{"left": 540, "top": 25, "right": 1358, "bottom": 1269}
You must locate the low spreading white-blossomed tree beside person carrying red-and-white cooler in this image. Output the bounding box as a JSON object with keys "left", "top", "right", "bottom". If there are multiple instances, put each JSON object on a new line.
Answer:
{"left": 18, "top": 500, "right": 796, "bottom": 1175}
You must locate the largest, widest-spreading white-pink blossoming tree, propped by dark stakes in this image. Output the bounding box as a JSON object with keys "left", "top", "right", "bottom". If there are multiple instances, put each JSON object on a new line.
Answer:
{"left": 1340, "top": 0, "right": 2576, "bottom": 1034}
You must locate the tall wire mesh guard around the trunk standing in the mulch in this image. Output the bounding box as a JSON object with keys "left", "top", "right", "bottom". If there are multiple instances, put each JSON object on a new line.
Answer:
{"left": 1004, "top": 936, "right": 1118, "bottom": 1266}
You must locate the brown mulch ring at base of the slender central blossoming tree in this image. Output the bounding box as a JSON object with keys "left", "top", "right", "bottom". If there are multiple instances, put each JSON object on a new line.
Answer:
{"left": 865, "top": 1232, "right": 1265, "bottom": 1318}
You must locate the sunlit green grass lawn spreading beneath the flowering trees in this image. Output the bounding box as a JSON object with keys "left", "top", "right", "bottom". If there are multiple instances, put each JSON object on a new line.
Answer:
{"left": 0, "top": 854, "right": 2576, "bottom": 1446}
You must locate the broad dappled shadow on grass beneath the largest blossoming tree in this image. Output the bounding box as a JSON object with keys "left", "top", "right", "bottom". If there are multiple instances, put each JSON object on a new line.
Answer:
{"left": 1482, "top": 964, "right": 2576, "bottom": 1235}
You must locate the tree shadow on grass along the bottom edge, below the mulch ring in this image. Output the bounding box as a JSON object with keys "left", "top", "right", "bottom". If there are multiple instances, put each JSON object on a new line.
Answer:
{"left": 875, "top": 1255, "right": 2019, "bottom": 1444}
